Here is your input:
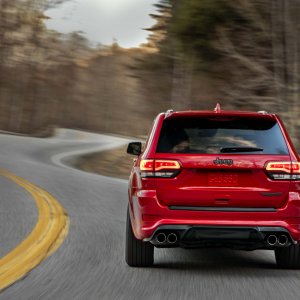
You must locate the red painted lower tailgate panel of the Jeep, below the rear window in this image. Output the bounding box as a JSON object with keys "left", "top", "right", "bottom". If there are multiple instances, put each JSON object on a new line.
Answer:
{"left": 155, "top": 154, "right": 290, "bottom": 208}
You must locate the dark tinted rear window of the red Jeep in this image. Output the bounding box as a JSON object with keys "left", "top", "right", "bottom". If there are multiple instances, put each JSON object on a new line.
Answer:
{"left": 157, "top": 117, "right": 288, "bottom": 155}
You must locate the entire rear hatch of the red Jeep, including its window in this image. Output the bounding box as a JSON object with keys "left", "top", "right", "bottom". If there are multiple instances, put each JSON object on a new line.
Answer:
{"left": 155, "top": 115, "right": 291, "bottom": 209}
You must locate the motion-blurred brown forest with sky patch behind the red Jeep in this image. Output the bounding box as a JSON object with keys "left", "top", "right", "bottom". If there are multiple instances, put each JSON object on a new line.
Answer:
{"left": 0, "top": 0, "right": 300, "bottom": 149}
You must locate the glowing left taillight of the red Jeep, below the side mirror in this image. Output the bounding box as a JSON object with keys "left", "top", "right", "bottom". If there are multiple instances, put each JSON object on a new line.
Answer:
{"left": 140, "top": 159, "right": 181, "bottom": 178}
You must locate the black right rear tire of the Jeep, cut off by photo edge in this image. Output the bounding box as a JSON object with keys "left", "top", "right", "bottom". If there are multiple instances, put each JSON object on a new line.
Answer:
{"left": 275, "top": 245, "right": 300, "bottom": 269}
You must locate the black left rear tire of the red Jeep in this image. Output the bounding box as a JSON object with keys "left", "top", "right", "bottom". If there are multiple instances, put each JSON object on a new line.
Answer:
{"left": 125, "top": 206, "right": 154, "bottom": 267}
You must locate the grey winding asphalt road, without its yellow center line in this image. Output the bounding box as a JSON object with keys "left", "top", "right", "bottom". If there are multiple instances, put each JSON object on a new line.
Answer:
{"left": 0, "top": 131, "right": 300, "bottom": 300}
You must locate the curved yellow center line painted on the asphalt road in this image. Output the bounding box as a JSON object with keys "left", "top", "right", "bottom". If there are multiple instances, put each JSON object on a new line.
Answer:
{"left": 0, "top": 169, "right": 70, "bottom": 291}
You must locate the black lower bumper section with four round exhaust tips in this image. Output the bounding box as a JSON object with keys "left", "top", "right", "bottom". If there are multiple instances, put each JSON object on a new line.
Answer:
{"left": 144, "top": 225, "right": 297, "bottom": 250}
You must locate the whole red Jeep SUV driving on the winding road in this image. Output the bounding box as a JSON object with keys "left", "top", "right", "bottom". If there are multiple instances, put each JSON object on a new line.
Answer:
{"left": 126, "top": 105, "right": 300, "bottom": 268}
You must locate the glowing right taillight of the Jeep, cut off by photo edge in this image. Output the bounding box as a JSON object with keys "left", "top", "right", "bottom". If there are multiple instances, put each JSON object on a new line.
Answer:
{"left": 266, "top": 161, "right": 300, "bottom": 180}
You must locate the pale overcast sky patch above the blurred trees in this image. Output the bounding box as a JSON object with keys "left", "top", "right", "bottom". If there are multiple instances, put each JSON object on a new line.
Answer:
{"left": 45, "top": 0, "right": 157, "bottom": 48}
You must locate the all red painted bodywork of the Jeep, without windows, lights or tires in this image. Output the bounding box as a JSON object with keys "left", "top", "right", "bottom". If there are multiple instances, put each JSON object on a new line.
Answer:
{"left": 129, "top": 111, "right": 300, "bottom": 241}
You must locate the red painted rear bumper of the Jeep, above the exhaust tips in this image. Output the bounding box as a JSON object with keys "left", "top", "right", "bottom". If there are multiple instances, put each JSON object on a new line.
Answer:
{"left": 130, "top": 190, "right": 300, "bottom": 242}
